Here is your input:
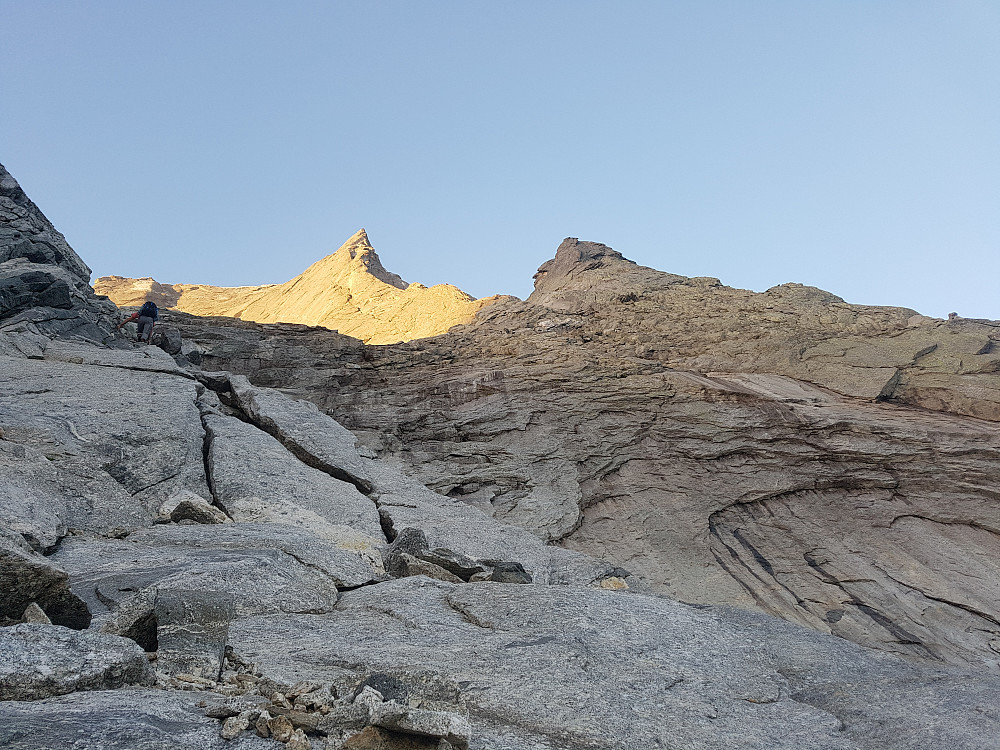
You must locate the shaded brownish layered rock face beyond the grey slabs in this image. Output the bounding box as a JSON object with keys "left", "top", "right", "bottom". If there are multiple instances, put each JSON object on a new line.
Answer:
{"left": 170, "top": 240, "right": 1000, "bottom": 668}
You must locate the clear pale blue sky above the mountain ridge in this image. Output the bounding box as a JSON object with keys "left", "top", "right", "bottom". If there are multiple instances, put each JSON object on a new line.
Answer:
{"left": 0, "top": 0, "right": 1000, "bottom": 318}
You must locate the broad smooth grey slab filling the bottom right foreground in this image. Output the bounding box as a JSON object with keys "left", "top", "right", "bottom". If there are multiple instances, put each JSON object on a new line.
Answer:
{"left": 230, "top": 577, "right": 1000, "bottom": 750}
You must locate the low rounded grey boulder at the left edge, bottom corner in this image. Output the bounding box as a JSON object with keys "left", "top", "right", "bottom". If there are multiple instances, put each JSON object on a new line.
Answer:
{"left": 0, "top": 624, "right": 155, "bottom": 701}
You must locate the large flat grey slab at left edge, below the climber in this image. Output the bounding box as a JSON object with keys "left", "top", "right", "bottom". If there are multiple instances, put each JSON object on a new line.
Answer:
{"left": 0, "top": 345, "right": 209, "bottom": 520}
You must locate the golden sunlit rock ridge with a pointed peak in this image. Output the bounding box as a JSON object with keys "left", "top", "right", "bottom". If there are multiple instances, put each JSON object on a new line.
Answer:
{"left": 94, "top": 229, "right": 512, "bottom": 344}
